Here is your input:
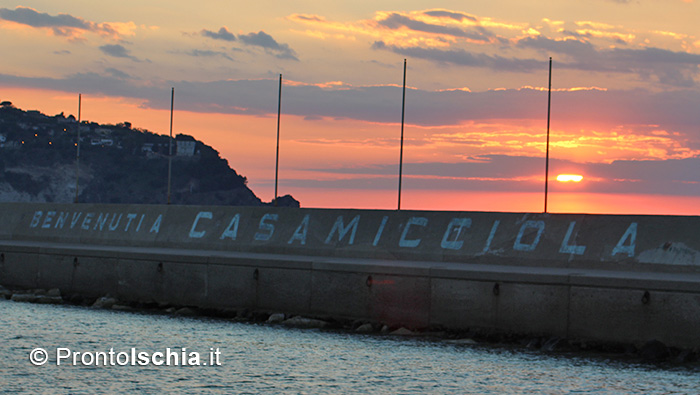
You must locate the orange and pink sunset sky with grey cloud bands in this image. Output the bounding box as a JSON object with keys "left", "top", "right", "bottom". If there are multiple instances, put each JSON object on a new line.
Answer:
{"left": 0, "top": 0, "right": 700, "bottom": 215}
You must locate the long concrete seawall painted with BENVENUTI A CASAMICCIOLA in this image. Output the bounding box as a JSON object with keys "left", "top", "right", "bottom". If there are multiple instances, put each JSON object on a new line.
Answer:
{"left": 0, "top": 204, "right": 700, "bottom": 348}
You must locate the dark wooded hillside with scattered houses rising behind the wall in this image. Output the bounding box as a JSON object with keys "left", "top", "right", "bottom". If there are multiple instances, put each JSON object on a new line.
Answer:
{"left": 0, "top": 101, "right": 299, "bottom": 207}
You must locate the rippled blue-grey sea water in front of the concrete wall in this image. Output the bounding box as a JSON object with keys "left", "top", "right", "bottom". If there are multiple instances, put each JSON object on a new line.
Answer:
{"left": 0, "top": 301, "right": 700, "bottom": 394}
